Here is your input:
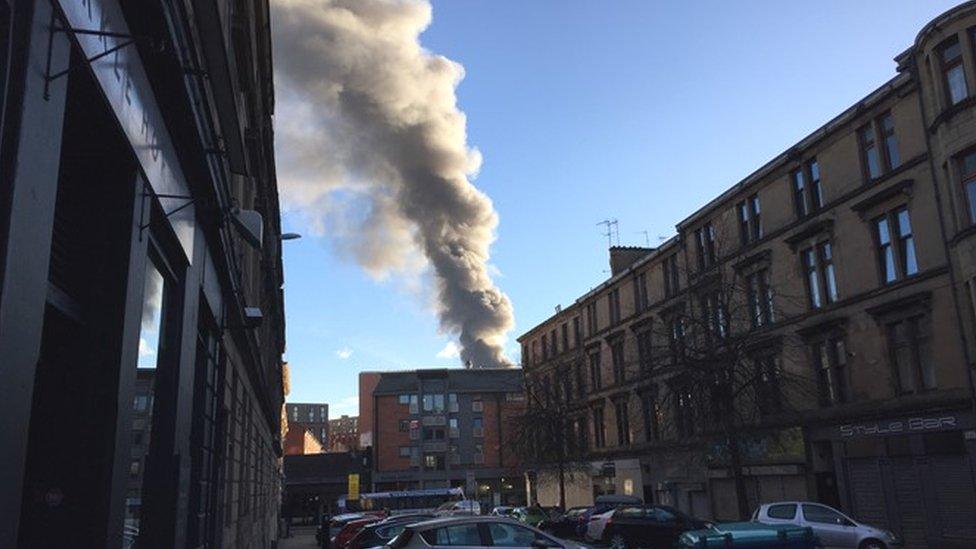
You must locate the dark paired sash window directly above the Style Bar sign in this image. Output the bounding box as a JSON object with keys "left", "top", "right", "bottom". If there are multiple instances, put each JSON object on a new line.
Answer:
{"left": 887, "top": 315, "right": 935, "bottom": 394}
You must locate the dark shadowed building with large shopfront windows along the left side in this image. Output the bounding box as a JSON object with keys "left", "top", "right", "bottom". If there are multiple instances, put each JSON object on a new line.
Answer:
{"left": 0, "top": 0, "right": 284, "bottom": 547}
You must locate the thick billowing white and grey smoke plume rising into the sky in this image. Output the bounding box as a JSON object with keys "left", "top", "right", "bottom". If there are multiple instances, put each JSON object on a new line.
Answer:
{"left": 272, "top": 0, "right": 514, "bottom": 367}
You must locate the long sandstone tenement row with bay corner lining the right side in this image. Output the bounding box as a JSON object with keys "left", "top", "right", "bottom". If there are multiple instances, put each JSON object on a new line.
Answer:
{"left": 519, "top": 2, "right": 976, "bottom": 547}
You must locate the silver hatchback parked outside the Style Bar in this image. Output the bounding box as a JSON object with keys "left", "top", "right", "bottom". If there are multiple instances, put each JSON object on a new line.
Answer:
{"left": 752, "top": 501, "right": 901, "bottom": 549}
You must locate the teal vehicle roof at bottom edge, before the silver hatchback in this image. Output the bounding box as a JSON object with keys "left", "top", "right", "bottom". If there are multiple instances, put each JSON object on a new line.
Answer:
{"left": 677, "top": 522, "right": 817, "bottom": 549}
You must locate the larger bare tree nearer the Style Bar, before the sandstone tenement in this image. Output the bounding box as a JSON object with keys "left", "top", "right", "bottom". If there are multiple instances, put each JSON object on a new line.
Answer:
{"left": 636, "top": 230, "right": 815, "bottom": 519}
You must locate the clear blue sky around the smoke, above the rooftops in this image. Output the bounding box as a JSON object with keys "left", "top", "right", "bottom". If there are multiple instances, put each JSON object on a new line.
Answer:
{"left": 284, "top": 0, "right": 958, "bottom": 417}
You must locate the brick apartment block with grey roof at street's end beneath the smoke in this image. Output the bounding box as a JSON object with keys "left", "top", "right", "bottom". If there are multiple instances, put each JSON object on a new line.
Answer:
{"left": 372, "top": 368, "right": 525, "bottom": 509}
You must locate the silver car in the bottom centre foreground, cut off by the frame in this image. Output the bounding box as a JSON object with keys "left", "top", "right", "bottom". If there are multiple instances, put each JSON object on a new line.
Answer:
{"left": 387, "top": 516, "right": 586, "bottom": 549}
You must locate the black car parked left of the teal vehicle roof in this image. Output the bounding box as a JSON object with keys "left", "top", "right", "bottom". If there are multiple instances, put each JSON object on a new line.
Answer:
{"left": 586, "top": 505, "right": 709, "bottom": 549}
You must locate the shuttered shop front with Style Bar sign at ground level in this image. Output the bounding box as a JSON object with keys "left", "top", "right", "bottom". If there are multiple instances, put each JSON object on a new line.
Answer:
{"left": 811, "top": 410, "right": 976, "bottom": 548}
